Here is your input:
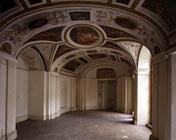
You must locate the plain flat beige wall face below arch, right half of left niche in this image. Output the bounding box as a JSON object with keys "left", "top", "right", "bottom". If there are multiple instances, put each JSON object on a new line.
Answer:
{"left": 28, "top": 71, "right": 47, "bottom": 120}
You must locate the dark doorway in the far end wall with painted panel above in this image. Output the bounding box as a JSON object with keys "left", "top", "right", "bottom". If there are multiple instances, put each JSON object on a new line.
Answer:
{"left": 97, "top": 68, "right": 117, "bottom": 111}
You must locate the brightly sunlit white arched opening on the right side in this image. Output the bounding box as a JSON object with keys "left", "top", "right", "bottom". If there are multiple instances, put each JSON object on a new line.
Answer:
{"left": 137, "top": 46, "right": 151, "bottom": 125}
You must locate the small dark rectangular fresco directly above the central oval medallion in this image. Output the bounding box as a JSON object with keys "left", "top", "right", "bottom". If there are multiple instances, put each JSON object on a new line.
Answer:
{"left": 69, "top": 12, "right": 90, "bottom": 21}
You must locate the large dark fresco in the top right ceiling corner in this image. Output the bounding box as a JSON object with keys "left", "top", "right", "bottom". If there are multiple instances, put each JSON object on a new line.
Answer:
{"left": 142, "top": 0, "right": 176, "bottom": 30}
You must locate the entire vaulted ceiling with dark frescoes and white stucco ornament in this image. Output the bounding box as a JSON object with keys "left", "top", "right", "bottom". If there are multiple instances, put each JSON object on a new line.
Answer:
{"left": 0, "top": 0, "right": 176, "bottom": 72}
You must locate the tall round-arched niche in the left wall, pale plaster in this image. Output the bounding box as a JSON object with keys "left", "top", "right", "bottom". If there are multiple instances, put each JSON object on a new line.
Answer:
{"left": 16, "top": 47, "right": 45, "bottom": 123}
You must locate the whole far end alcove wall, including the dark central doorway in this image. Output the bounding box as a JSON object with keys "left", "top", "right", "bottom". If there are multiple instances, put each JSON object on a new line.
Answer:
{"left": 77, "top": 61, "right": 133, "bottom": 114}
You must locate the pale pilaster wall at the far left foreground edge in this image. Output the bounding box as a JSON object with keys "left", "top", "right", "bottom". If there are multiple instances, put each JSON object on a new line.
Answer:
{"left": 0, "top": 52, "right": 17, "bottom": 140}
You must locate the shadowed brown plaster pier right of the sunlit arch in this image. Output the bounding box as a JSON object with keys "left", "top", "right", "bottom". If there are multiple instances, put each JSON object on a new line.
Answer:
{"left": 151, "top": 53, "right": 171, "bottom": 140}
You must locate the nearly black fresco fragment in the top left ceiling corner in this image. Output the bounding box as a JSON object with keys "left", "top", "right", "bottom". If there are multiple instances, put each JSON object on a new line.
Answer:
{"left": 0, "top": 0, "right": 17, "bottom": 13}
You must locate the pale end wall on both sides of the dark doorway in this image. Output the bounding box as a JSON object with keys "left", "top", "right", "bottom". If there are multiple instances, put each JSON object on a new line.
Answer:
{"left": 77, "top": 63, "right": 133, "bottom": 113}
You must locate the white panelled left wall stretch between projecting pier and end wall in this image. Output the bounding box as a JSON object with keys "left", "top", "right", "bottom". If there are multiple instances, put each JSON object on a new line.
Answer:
{"left": 49, "top": 73, "right": 76, "bottom": 118}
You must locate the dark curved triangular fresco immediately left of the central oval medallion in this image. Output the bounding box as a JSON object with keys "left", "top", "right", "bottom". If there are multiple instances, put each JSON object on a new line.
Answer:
{"left": 28, "top": 27, "right": 64, "bottom": 42}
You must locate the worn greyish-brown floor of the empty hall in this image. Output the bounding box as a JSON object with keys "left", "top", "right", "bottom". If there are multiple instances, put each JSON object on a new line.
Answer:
{"left": 17, "top": 111, "right": 151, "bottom": 140}
